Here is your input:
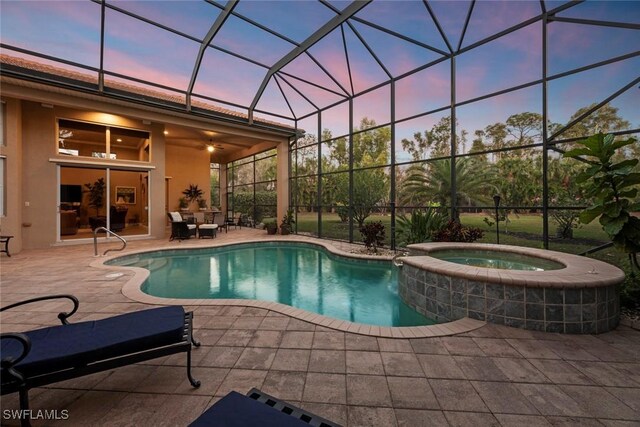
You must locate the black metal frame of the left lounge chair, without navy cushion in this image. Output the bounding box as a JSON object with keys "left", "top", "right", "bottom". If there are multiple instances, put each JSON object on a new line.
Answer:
{"left": 0, "top": 295, "right": 200, "bottom": 426}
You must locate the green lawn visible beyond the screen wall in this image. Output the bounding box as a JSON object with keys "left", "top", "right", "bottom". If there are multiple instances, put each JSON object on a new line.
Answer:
{"left": 297, "top": 212, "right": 628, "bottom": 267}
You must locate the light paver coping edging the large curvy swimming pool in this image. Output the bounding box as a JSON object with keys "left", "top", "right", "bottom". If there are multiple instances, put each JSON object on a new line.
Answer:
{"left": 89, "top": 235, "right": 486, "bottom": 338}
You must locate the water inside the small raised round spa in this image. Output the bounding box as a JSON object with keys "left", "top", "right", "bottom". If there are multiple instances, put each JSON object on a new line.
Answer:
{"left": 429, "top": 249, "right": 565, "bottom": 271}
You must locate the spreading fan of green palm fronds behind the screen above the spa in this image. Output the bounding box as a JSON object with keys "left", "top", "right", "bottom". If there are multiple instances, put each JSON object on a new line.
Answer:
{"left": 399, "top": 157, "right": 497, "bottom": 216}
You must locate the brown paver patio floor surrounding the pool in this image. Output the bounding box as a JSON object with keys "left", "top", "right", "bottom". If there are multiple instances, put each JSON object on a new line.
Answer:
{"left": 0, "top": 229, "right": 640, "bottom": 426}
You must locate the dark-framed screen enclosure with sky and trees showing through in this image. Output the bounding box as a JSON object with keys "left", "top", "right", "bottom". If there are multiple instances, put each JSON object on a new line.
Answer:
{"left": 0, "top": 0, "right": 640, "bottom": 253}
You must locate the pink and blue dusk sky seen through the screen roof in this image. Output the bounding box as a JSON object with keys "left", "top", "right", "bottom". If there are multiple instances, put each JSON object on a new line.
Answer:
{"left": 0, "top": 0, "right": 640, "bottom": 145}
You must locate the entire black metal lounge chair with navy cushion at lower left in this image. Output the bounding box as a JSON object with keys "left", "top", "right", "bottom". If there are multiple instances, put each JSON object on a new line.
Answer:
{"left": 0, "top": 295, "right": 200, "bottom": 426}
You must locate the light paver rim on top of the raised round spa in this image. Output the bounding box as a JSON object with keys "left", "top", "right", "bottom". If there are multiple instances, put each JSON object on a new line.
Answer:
{"left": 402, "top": 242, "right": 625, "bottom": 288}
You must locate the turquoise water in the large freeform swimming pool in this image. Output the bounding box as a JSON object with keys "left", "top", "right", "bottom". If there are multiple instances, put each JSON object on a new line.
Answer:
{"left": 108, "top": 242, "right": 435, "bottom": 326}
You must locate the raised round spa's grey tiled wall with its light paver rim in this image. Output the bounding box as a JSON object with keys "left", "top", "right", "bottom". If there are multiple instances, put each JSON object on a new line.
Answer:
{"left": 398, "top": 243, "right": 624, "bottom": 334}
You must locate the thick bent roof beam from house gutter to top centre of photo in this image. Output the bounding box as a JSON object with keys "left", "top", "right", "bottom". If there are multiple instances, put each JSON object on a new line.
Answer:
{"left": 249, "top": 0, "right": 371, "bottom": 123}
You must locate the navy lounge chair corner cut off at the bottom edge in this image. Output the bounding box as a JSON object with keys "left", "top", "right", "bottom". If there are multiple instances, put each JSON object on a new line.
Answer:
{"left": 189, "top": 388, "right": 339, "bottom": 427}
